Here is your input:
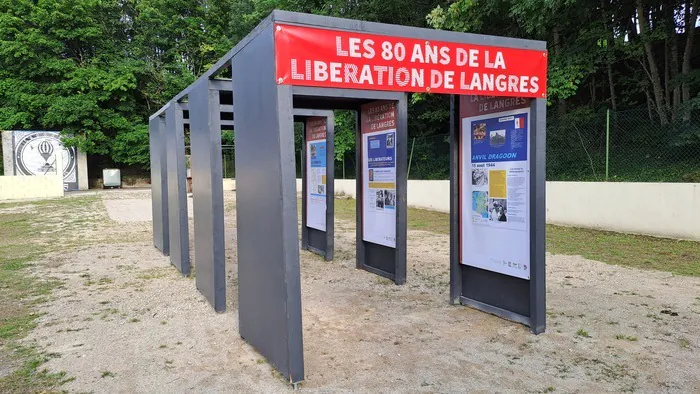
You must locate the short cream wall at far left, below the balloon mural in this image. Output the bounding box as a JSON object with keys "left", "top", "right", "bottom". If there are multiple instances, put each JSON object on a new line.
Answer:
{"left": 0, "top": 175, "right": 63, "bottom": 200}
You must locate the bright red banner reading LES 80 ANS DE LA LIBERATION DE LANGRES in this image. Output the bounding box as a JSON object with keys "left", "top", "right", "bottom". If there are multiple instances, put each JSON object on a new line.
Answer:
{"left": 275, "top": 24, "right": 547, "bottom": 98}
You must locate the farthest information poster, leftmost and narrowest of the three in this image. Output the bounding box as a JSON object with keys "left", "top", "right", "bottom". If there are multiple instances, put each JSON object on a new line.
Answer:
{"left": 306, "top": 117, "right": 326, "bottom": 231}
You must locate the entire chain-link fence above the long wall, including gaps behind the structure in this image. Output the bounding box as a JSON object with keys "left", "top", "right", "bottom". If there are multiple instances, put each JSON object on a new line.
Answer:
{"left": 216, "top": 108, "right": 700, "bottom": 182}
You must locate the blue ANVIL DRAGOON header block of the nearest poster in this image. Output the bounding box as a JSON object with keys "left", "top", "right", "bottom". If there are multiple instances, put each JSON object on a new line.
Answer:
{"left": 471, "top": 113, "right": 528, "bottom": 163}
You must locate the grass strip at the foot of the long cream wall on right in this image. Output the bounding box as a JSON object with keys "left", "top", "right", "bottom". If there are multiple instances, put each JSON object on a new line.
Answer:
{"left": 330, "top": 198, "right": 700, "bottom": 276}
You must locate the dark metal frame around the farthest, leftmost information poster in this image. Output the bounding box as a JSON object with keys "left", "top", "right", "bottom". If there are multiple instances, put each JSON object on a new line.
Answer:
{"left": 294, "top": 109, "right": 335, "bottom": 261}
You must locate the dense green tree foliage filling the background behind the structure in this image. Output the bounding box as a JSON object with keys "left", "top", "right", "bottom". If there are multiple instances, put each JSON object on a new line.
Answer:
{"left": 0, "top": 0, "right": 700, "bottom": 178}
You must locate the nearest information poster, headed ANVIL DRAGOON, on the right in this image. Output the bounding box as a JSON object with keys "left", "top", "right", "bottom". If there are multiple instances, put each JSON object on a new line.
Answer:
{"left": 460, "top": 96, "right": 530, "bottom": 279}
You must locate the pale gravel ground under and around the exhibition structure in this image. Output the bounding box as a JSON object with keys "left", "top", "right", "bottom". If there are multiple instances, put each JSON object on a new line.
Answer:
{"left": 27, "top": 191, "right": 700, "bottom": 393}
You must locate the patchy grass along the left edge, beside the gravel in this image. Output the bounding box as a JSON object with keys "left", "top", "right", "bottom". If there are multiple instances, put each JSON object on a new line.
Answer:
{"left": 0, "top": 202, "right": 99, "bottom": 393}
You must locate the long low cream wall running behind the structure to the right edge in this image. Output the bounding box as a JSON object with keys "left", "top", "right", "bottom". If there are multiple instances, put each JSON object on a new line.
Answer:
{"left": 297, "top": 179, "right": 700, "bottom": 241}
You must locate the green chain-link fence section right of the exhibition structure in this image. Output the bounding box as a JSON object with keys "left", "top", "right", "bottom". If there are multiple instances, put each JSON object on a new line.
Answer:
{"left": 547, "top": 108, "right": 700, "bottom": 182}
